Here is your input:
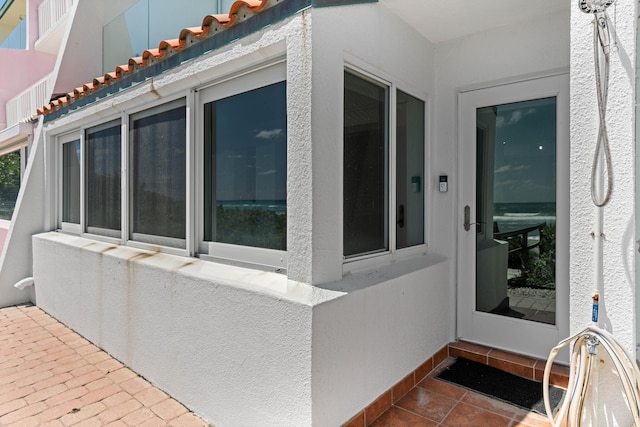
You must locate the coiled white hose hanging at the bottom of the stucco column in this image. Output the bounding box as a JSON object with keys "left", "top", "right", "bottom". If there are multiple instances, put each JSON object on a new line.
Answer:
{"left": 542, "top": 326, "right": 640, "bottom": 427}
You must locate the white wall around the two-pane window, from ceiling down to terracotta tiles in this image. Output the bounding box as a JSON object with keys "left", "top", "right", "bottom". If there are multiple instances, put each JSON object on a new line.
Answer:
{"left": 312, "top": 3, "right": 454, "bottom": 426}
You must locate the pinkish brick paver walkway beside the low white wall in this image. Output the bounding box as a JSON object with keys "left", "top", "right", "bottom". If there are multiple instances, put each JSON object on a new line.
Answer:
{"left": 0, "top": 305, "right": 209, "bottom": 427}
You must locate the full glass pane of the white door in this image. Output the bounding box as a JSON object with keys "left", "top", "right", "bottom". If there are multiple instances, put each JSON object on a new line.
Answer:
{"left": 476, "top": 97, "right": 557, "bottom": 324}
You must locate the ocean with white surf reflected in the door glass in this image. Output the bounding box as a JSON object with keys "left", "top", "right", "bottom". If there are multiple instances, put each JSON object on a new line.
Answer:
{"left": 493, "top": 202, "right": 556, "bottom": 233}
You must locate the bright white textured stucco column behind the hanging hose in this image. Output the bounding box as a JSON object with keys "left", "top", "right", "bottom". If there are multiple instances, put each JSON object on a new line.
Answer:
{"left": 570, "top": 0, "right": 637, "bottom": 352}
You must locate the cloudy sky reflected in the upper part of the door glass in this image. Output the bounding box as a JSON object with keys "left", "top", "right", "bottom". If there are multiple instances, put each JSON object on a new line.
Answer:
{"left": 494, "top": 98, "right": 556, "bottom": 203}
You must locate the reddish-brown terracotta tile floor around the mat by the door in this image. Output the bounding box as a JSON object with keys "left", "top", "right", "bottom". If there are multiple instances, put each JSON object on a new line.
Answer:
{"left": 343, "top": 341, "right": 569, "bottom": 427}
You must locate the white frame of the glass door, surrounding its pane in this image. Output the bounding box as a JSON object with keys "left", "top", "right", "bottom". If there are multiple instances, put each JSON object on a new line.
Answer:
{"left": 456, "top": 72, "right": 570, "bottom": 359}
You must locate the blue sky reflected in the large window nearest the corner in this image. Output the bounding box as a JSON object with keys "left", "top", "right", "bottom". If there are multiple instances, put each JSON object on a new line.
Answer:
{"left": 215, "top": 82, "right": 287, "bottom": 204}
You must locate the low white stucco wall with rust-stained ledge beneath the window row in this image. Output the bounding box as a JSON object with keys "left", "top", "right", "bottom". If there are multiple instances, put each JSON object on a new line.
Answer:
{"left": 34, "top": 233, "right": 324, "bottom": 426}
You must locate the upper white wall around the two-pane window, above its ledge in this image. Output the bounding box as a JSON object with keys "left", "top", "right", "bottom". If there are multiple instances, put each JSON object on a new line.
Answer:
{"left": 312, "top": 3, "right": 439, "bottom": 283}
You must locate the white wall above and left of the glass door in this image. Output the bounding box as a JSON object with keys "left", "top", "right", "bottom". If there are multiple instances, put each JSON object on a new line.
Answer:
{"left": 431, "top": 10, "right": 569, "bottom": 352}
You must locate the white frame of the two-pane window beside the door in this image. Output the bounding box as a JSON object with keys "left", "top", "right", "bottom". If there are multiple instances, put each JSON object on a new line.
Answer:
{"left": 341, "top": 64, "right": 432, "bottom": 274}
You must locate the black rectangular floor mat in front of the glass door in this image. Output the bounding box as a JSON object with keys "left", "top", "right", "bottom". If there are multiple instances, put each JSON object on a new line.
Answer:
{"left": 437, "top": 357, "right": 564, "bottom": 415}
